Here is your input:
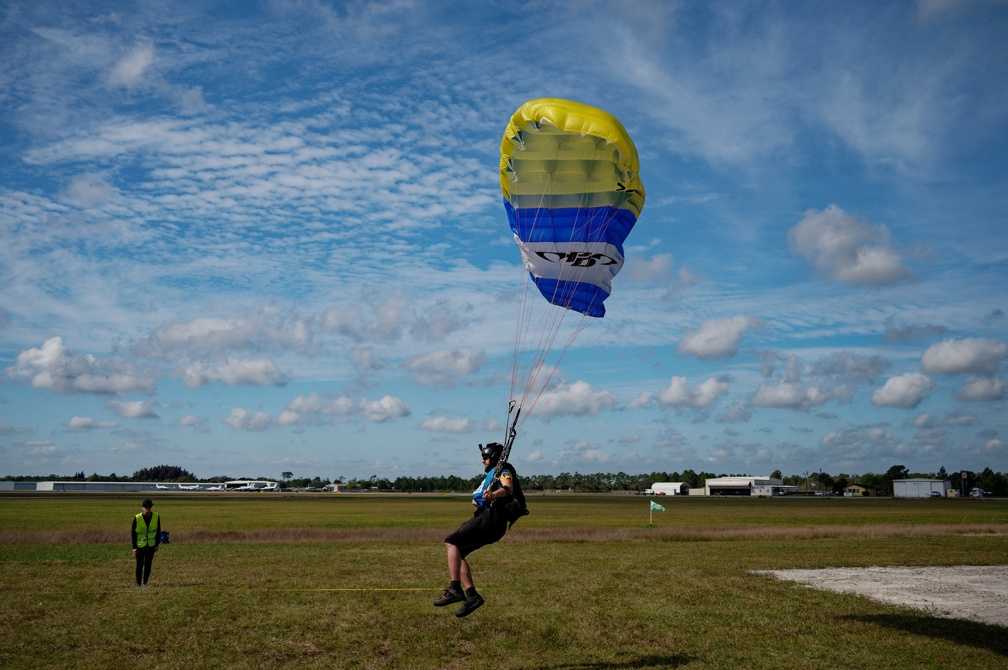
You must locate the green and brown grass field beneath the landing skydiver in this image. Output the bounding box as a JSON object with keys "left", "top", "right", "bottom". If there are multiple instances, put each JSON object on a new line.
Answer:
{"left": 0, "top": 494, "right": 1008, "bottom": 670}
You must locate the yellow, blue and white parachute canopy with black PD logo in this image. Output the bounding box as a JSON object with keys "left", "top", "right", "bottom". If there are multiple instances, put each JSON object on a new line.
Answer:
{"left": 500, "top": 98, "right": 644, "bottom": 316}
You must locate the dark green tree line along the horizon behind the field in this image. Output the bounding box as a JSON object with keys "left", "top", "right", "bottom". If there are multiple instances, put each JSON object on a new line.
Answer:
{"left": 0, "top": 465, "right": 1008, "bottom": 497}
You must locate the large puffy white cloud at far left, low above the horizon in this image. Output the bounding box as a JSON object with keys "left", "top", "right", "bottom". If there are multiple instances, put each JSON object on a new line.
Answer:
{"left": 6, "top": 337, "right": 154, "bottom": 395}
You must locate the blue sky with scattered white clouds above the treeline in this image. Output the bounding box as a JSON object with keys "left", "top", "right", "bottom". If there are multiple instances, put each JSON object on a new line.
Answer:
{"left": 0, "top": 0, "right": 1008, "bottom": 479}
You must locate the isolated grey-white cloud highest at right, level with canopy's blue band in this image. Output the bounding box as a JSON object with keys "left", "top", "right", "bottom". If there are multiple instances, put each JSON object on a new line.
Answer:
{"left": 787, "top": 205, "right": 910, "bottom": 286}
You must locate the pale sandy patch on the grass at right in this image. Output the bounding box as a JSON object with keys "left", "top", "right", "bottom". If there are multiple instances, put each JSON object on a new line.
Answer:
{"left": 758, "top": 565, "right": 1008, "bottom": 627}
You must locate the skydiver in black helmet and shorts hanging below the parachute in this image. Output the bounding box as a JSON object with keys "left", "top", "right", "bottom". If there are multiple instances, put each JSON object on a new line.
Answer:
{"left": 434, "top": 442, "right": 528, "bottom": 617}
